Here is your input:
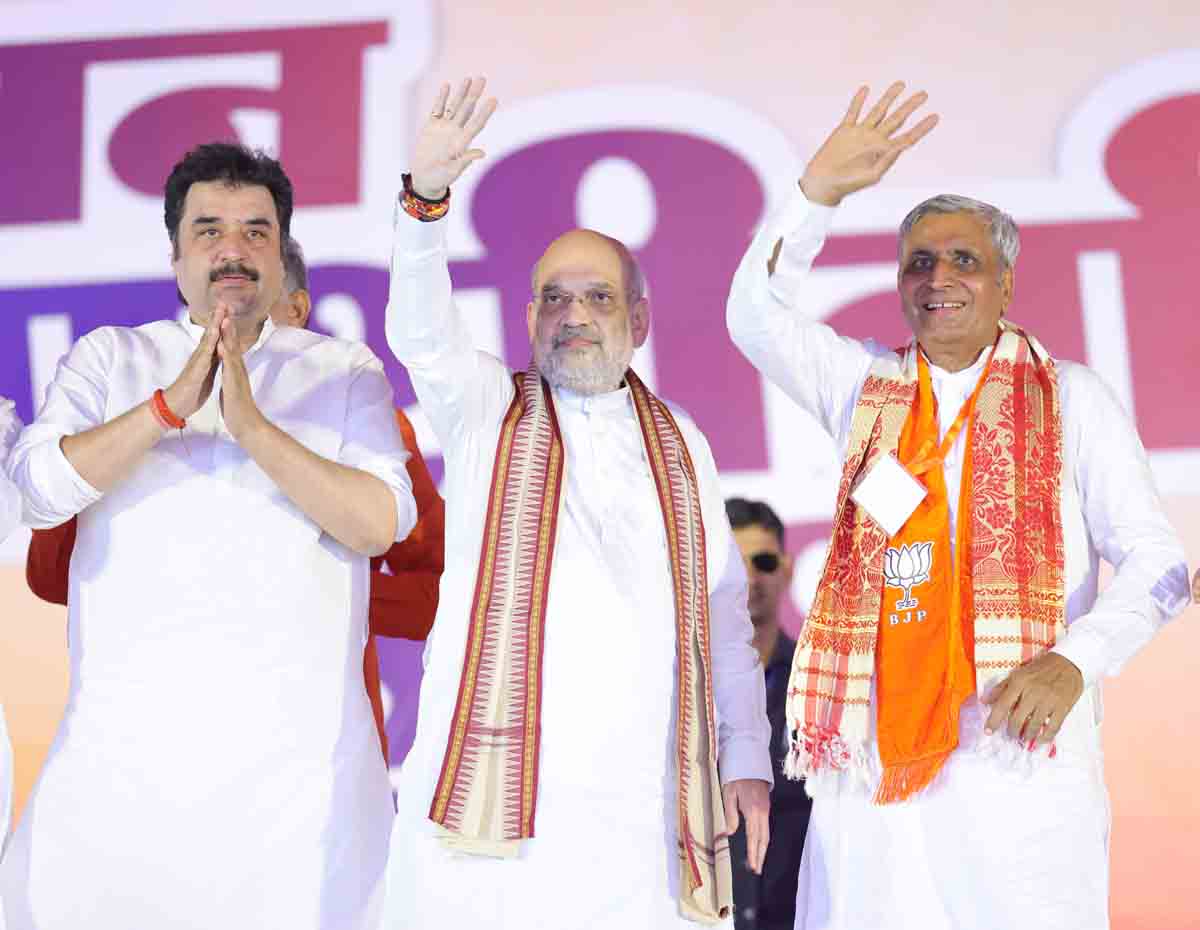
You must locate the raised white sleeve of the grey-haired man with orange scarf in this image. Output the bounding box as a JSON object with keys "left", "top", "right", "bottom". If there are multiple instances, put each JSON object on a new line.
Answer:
{"left": 726, "top": 187, "right": 882, "bottom": 442}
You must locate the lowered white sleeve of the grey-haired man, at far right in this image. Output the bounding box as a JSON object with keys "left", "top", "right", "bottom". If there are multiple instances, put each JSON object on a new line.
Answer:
{"left": 1054, "top": 365, "right": 1190, "bottom": 685}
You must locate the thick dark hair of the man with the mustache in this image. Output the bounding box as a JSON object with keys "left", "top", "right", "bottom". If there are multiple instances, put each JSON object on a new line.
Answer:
{"left": 162, "top": 142, "right": 292, "bottom": 258}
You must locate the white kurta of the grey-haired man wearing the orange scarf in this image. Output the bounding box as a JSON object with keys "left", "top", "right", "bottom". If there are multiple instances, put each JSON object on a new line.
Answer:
{"left": 728, "top": 192, "right": 1188, "bottom": 930}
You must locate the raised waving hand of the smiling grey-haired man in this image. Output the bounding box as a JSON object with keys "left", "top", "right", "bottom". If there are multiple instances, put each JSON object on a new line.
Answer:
{"left": 800, "top": 82, "right": 937, "bottom": 206}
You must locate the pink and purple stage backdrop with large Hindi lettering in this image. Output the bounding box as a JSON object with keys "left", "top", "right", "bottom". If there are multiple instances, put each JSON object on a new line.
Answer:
{"left": 0, "top": 0, "right": 1200, "bottom": 930}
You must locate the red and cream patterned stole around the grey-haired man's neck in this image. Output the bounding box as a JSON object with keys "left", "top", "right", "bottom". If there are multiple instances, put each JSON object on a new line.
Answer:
{"left": 784, "top": 322, "right": 1066, "bottom": 791}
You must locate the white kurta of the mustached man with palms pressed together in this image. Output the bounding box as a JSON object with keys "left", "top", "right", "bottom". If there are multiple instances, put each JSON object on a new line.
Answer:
{"left": 0, "top": 322, "right": 416, "bottom": 930}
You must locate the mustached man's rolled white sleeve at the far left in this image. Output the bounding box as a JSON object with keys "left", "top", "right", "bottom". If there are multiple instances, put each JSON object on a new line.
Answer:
{"left": 8, "top": 329, "right": 108, "bottom": 529}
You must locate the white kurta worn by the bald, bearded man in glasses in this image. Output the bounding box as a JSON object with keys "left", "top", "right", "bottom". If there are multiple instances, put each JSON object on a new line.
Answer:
{"left": 385, "top": 214, "right": 772, "bottom": 930}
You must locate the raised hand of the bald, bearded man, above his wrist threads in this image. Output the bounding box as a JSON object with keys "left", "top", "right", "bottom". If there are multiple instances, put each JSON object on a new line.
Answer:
{"left": 412, "top": 78, "right": 496, "bottom": 200}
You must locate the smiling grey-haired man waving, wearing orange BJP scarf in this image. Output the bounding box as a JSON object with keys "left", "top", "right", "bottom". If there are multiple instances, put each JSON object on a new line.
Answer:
{"left": 728, "top": 84, "right": 1188, "bottom": 930}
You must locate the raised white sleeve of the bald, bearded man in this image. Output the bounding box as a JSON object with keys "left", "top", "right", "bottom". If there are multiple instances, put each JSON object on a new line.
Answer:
{"left": 386, "top": 208, "right": 514, "bottom": 448}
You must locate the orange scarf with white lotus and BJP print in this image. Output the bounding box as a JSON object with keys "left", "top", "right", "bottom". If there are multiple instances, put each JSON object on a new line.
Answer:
{"left": 875, "top": 354, "right": 990, "bottom": 804}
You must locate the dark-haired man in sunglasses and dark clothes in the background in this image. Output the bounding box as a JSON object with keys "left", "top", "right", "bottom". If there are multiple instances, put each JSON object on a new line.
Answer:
{"left": 725, "top": 497, "right": 812, "bottom": 930}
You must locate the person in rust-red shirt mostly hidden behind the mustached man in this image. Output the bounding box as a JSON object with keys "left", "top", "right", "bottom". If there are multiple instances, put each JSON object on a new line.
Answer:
{"left": 25, "top": 239, "right": 445, "bottom": 763}
